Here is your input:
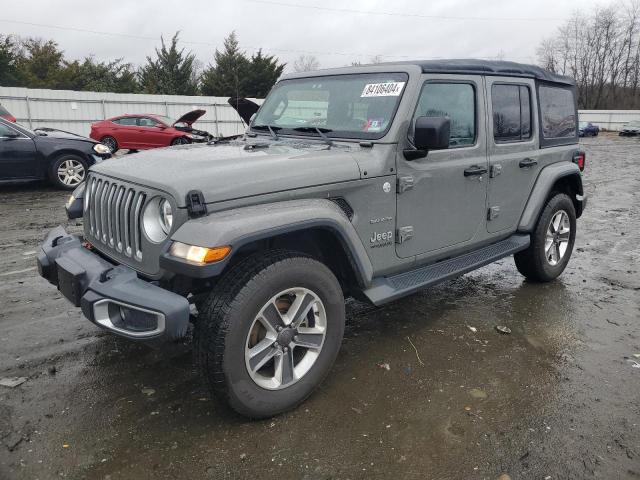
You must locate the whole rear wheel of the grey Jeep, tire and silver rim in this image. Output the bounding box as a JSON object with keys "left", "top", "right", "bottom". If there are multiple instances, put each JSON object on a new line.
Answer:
{"left": 514, "top": 193, "right": 576, "bottom": 282}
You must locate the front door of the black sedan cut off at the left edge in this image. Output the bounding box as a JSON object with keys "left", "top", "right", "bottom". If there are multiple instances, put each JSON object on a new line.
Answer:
{"left": 0, "top": 123, "right": 38, "bottom": 180}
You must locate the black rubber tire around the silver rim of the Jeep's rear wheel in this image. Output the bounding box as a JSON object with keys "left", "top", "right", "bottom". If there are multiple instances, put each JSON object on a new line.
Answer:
{"left": 514, "top": 193, "right": 576, "bottom": 282}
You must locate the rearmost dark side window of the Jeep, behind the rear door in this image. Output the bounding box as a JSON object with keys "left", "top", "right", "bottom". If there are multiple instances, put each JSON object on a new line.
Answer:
{"left": 538, "top": 85, "right": 577, "bottom": 139}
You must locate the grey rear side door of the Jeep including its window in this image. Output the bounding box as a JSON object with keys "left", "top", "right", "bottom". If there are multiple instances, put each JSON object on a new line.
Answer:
{"left": 486, "top": 77, "right": 540, "bottom": 233}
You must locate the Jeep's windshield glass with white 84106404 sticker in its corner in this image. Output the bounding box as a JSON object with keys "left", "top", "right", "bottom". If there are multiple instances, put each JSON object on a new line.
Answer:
{"left": 251, "top": 73, "right": 408, "bottom": 139}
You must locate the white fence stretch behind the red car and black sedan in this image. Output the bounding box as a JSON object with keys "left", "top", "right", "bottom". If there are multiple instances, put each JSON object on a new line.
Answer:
{"left": 0, "top": 87, "right": 261, "bottom": 136}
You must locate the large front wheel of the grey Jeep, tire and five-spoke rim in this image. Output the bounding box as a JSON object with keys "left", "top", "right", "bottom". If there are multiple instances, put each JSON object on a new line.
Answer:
{"left": 194, "top": 251, "right": 345, "bottom": 418}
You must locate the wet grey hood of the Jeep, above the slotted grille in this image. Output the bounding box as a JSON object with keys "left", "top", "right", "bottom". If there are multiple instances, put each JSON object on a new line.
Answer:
{"left": 92, "top": 141, "right": 360, "bottom": 207}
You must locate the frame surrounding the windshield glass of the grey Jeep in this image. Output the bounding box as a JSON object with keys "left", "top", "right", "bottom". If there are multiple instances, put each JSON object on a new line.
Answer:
{"left": 249, "top": 70, "right": 410, "bottom": 142}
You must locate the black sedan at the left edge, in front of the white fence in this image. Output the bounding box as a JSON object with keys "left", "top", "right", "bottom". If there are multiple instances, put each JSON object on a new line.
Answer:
{"left": 0, "top": 119, "right": 111, "bottom": 189}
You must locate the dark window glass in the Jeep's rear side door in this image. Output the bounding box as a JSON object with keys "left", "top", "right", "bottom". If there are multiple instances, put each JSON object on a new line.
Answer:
{"left": 491, "top": 84, "right": 531, "bottom": 143}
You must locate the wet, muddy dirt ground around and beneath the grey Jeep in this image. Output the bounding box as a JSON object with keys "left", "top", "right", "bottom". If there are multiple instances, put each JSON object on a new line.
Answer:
{"left": 0, "top": 135, "right": 640, "bottom": 480}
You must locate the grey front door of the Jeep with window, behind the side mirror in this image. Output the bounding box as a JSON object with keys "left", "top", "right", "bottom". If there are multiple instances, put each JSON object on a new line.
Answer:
{"left": 396, "top": 76, "right": 488, "bottom": 258}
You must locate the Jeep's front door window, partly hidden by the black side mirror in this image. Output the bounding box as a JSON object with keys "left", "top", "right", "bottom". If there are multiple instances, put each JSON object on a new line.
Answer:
{"left": 413, "top": 83, "right": 476, "bottom": 147}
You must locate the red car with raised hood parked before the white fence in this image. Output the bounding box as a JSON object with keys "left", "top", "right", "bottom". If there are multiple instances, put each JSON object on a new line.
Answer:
{"left": 89, "top": 110, "right": 212, "bottom": 153}
